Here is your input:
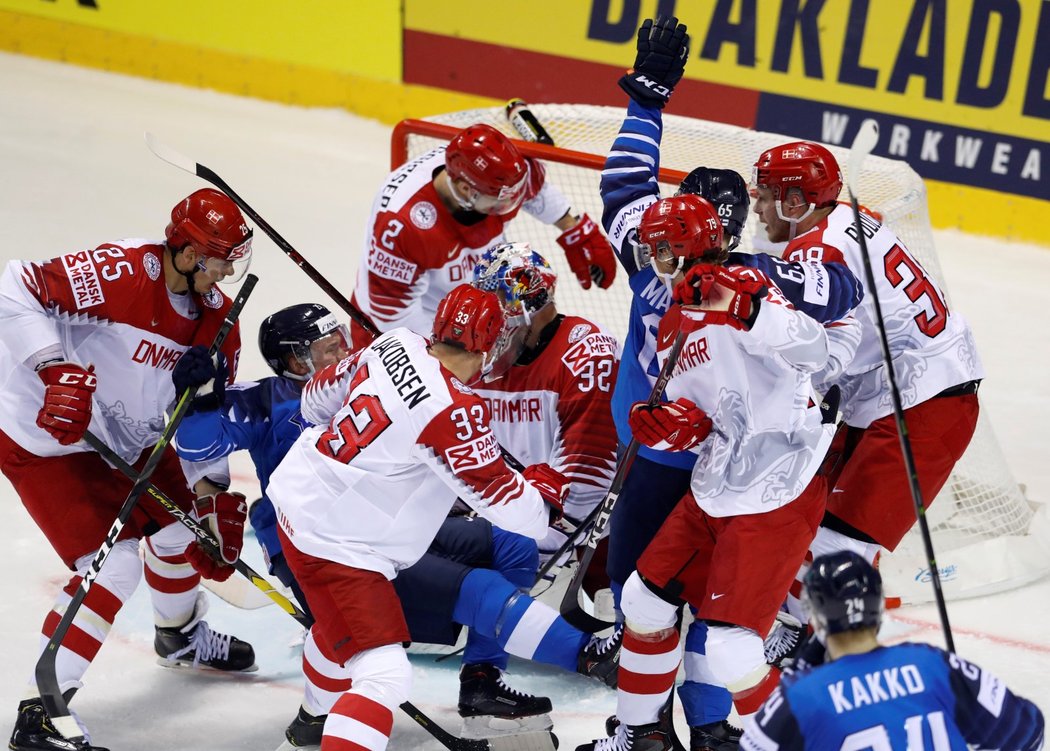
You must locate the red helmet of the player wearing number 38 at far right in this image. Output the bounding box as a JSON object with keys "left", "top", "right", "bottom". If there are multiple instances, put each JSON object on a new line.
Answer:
{"left": 751, "top": 141, "right": 842, "bottom": 208}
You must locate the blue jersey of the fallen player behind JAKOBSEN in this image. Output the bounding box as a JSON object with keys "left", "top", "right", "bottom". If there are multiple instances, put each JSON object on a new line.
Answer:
{"left": 174, "top": 376, "right": 309, "bottom": 573}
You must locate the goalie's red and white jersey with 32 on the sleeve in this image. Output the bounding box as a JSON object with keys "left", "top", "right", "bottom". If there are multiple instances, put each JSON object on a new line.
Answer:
{"left": 475, "top": 316, "right": 620, "bottom": 519}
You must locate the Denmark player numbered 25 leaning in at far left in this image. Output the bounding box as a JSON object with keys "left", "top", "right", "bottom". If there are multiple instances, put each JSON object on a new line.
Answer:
{"left": 0, "top": 189, "right": 255, "bottom": 751}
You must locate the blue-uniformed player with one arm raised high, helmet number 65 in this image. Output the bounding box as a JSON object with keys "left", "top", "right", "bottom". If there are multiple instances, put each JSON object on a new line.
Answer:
{"left": 601, "top": 17, "right": 860, "bottom": 751}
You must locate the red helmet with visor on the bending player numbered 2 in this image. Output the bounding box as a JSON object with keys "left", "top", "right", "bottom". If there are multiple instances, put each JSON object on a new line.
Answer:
{"left": 445, "top": 124, "right": 528, "bottom": 215}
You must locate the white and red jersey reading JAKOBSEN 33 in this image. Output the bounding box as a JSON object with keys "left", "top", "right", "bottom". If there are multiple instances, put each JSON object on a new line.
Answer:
{"left": 267, "top": 328, "right": 549, "bottom": 579}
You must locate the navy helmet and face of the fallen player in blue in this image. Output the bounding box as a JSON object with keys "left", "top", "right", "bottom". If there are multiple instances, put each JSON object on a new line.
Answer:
{"left": 259, "top": 303, "right": 351, "bottom": 381}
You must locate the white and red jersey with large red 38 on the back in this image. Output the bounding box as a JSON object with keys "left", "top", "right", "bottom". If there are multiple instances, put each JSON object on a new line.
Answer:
{"left": 783, "top": 204, "right": 984, "bottom": 427}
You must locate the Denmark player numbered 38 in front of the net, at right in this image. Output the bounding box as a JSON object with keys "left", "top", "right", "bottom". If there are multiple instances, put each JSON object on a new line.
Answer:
{"left": 753, "top": 142, "right": 984, "bottom": 616}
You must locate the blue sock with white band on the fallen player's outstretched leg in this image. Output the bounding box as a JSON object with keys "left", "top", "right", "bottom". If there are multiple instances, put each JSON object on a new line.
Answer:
{"left": 453, "top": 568, "right": 588, "bottom": 671}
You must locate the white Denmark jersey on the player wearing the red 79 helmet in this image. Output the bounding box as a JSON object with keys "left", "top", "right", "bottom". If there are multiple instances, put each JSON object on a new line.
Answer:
{"left": 657, "top": 287, "right": 835, "bottom": 517}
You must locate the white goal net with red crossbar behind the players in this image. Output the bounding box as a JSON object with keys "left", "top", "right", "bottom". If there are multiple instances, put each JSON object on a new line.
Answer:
{"left": 392, "top": 104, "right": 1050, "bottom": 604}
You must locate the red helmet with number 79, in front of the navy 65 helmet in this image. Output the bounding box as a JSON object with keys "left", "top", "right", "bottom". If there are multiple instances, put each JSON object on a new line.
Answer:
{"left": 638, "top": 193, "right": 725, "bottom": 265}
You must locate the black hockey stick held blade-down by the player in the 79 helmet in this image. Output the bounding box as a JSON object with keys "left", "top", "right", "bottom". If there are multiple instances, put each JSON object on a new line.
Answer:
{"left": 559, "top": 331, "right": 686, "bottom": 633}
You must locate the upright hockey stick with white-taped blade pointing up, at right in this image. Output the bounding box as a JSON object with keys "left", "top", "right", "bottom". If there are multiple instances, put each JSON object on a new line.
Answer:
{"left": 846, "top": 120, "right": 956, "bottom": 652}
